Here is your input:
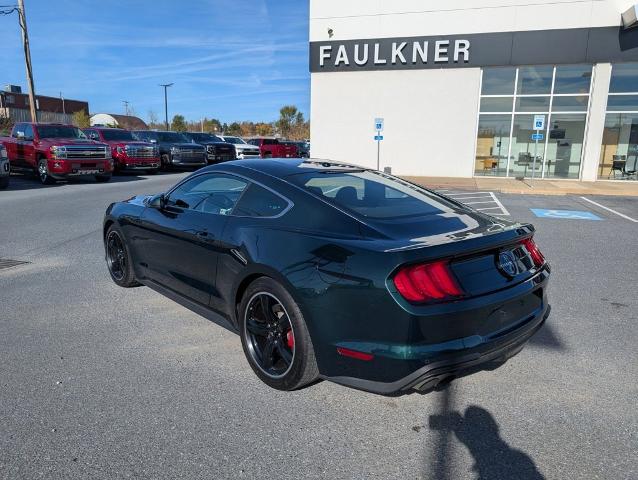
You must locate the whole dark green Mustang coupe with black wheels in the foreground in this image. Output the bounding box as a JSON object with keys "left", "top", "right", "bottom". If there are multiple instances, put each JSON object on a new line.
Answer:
{"left": 104, "top": 159, "right": 550, "bottom": 394}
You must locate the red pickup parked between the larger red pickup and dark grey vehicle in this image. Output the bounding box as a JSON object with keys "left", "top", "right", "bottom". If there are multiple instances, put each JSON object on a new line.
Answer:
{"left": 83, "top": 127, "right": 161, "bottom": 174}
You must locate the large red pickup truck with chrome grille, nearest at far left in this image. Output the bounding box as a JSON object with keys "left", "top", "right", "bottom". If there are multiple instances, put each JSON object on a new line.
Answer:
{"left": 0, "top": 123, "right": 113, "bottom": 184}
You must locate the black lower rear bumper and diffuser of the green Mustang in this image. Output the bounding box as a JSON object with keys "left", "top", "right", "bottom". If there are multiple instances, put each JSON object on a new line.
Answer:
{"left": 324, "top": 304, "right": 551, "bottom": 395}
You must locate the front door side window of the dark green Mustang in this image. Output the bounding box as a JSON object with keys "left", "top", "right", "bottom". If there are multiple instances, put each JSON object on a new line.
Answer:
{"left": 167, "top": 173, "right": 248, "bottom": 215}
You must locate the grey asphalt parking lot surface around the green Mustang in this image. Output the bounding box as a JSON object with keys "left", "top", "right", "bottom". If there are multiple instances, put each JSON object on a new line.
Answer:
{"left": 0, "top": 174, "right": 638, "bottom": 480}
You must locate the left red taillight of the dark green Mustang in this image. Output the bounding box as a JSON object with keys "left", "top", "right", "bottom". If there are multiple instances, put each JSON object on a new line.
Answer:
{"left": 394, "top": 260, "right": 464, "bottom": 303}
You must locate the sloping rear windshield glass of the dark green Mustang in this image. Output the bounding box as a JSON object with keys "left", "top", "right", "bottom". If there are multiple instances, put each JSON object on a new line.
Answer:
{"left": 288, "top": 170, "right": 453, "bottom": 218}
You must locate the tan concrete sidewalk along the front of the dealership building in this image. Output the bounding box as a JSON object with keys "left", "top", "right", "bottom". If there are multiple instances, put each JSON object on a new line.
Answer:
{"left": 403, "top": 177, "right": 638, "bottom": 197}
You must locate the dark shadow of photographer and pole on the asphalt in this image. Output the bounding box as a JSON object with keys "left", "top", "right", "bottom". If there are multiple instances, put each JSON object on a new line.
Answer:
{"left": 428, "top": 385, "right": 545, "bottom": 480}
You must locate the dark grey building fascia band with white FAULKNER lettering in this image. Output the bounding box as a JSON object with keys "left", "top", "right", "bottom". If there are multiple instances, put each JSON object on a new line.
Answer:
{"left": 310, "top": 27, "right": 638, "bottom": 73}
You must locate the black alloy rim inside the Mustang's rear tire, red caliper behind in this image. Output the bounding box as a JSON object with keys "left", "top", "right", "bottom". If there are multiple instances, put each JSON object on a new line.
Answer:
{"left": 245, "top": 292, "right": 295, "bottom": 378}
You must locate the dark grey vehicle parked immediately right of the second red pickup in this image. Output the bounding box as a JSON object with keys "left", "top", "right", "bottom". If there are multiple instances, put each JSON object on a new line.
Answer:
{"left": 133, "top": 130, "right": 208, "bottom": 169}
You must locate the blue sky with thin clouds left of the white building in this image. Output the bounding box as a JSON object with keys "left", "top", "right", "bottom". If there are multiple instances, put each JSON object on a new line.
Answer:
{"left": 0, "top": 0, "right": 310, "bottom": 123}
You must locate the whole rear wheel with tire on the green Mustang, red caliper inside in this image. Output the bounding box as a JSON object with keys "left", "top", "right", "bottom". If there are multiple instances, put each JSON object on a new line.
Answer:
{"left": 238, "top": 277, "right": 319, "bottom": 391}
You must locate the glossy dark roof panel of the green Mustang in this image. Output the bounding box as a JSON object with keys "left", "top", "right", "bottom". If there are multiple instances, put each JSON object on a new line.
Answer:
{"left": 208, "top": 158, "right": 367, "bottom": 178}
